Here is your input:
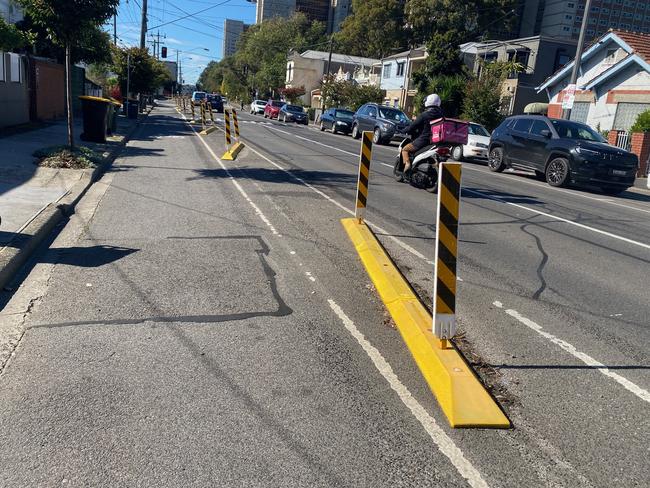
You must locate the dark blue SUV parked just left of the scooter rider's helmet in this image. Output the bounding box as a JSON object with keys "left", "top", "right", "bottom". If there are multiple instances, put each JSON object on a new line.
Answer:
{"left": 352, "top": 103, "right": 410, "bottom": 144}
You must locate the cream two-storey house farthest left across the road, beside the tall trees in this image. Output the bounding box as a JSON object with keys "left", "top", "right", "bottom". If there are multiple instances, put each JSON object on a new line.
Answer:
{"left": 285, "top": 50, "right": 379, "bottom": 105}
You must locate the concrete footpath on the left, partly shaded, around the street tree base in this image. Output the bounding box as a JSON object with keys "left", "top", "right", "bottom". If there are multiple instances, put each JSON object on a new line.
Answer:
{"left": 0, "top": 110, "right": 144, "bottom": 287}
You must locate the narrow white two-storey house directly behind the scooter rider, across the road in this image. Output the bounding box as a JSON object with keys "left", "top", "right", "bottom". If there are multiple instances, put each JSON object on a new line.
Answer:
{"left": 379, "top": 47, "right": 428, "bottom": 114}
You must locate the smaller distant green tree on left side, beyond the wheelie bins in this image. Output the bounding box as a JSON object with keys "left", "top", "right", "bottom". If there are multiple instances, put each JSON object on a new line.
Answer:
{"left": 112, "top": 47, "right": 170, "bottom": 97}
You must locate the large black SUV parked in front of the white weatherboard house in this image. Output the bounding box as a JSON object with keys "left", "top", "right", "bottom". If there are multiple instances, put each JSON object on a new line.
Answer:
{"left": 488, "top": 115, "right": 639, "bottom": 194}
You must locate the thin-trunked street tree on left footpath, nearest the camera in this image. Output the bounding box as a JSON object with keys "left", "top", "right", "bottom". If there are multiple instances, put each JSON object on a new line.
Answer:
{"left": 19, "top": 0, "right": 119, "bottom": 147}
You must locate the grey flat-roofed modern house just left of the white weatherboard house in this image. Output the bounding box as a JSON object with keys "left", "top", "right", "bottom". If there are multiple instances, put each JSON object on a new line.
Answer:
{"left": 460, "top": 36, "right": 577, "bottom": 115}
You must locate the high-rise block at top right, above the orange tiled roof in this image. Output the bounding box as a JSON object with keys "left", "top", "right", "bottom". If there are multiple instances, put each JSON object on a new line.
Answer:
{"left": 518, "top": 0, "right": 650, "bottom": 42}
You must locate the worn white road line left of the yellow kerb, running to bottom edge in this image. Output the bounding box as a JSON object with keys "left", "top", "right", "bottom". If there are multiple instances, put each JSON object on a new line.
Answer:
{"left": 327, "top": 299, "right": 489, "bottom": 488}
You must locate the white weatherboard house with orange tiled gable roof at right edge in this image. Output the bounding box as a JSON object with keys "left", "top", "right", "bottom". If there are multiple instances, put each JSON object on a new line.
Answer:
{"left": 537, "top": 30, "right": 650, "bottom": 131}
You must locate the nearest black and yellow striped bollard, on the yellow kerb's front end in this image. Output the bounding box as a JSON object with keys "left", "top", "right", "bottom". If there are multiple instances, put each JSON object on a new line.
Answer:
{"left": 433, "top": 163, "right": 462, "bottom": 349}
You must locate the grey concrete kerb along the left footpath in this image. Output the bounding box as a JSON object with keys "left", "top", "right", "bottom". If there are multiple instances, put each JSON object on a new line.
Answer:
{"left": 0, "top": 108, "right": 153, "bottom": 289}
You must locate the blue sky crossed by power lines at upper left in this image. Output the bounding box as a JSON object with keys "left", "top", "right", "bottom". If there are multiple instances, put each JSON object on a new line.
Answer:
{"left": 106, "top": 0, "right": 255, "bottom": 83}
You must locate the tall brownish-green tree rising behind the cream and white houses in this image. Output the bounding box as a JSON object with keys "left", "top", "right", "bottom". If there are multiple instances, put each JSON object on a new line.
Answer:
{"left": 335, "top": 0, "right": 408, "bottom": 59}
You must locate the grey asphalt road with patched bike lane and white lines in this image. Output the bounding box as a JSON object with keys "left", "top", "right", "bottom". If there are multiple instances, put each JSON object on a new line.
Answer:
{"left": 0, "top": 101, "right": 650, "bottom": 487}
